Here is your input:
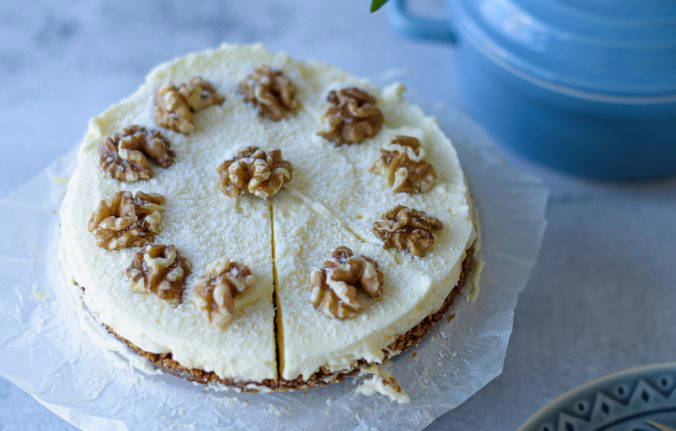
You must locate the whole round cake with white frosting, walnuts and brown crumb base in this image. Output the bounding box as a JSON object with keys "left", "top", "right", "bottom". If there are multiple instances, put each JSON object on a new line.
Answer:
{"left": 61, "top": 45, "right": 477, "bottom": 391}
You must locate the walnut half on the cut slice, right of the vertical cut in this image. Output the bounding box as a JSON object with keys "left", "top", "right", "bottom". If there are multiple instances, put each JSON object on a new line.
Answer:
{"left": 310, "top": 246, "right": 383, "bottom": 320}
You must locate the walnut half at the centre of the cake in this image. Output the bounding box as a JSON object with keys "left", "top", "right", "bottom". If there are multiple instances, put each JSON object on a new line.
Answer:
{"left": 218, "top": 146, "right": 293, "bottom": 199}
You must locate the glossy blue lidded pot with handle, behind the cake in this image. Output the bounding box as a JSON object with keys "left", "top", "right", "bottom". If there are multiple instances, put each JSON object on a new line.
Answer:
{"left": 390, "top": 0, "right": 676, "bottom": 180}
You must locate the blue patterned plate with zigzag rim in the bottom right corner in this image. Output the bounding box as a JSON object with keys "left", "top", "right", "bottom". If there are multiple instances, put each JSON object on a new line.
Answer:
{"left": 519, "top": 362, "right": 676, "bottom": 431}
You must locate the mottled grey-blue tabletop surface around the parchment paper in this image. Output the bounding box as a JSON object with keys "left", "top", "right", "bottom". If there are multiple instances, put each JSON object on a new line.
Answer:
{"left": 0, "top": 0, "right": 676, "bottom": 430}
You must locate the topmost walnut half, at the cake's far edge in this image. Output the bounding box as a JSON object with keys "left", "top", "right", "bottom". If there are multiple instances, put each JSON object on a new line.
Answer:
{"left": 239, "top": 66, "right": 300, "bottom": 121}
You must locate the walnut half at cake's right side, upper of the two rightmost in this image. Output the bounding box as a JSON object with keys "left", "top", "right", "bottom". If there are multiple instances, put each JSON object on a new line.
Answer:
{"left": 371, "top": 135, "right": 436, "bottom": 193}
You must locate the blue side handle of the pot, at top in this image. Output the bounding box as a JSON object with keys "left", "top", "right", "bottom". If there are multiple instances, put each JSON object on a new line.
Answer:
{"left": 389, "top": 0, "right": 456, "bottom": 43}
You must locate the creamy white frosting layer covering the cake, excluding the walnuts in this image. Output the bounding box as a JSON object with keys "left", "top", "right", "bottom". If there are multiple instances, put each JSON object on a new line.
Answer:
{"left": 61, "top": 45, "right": 475, "bottom": 381}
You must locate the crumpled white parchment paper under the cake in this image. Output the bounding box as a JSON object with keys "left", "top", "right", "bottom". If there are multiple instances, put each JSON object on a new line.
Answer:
{"left": 0, "top": 106, "right": 548, "bottom": 430}
